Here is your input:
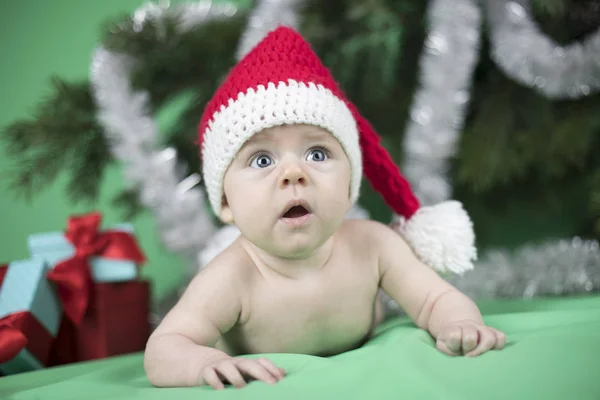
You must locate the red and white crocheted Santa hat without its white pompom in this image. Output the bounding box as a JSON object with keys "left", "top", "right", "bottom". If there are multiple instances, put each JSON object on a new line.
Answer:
{"left": 198, "top": 27, "right": 419, "bottom": 218}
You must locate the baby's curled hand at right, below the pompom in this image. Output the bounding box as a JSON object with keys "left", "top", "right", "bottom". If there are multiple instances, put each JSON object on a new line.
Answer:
{"left": 436, "top": 320, "right": 506, "bottom": 357}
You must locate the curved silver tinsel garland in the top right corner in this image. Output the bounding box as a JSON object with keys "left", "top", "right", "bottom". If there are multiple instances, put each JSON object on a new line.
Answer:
{"left": 486, "top": 0, "right": 600, "bottom": 99}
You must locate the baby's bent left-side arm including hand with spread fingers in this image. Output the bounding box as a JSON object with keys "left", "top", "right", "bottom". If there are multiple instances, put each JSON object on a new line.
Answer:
{"left": 144, "top": 265, "right": 283, "bottom": 389}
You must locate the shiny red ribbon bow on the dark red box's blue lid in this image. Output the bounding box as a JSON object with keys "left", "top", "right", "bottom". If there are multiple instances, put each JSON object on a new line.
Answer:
{"left": 48, "top": 212, "right": 146, "bottom": 325}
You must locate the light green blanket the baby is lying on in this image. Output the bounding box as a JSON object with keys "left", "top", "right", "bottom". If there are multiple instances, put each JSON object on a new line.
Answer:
{"left": 0, "top": 296, "right": 600, "bottom": 400}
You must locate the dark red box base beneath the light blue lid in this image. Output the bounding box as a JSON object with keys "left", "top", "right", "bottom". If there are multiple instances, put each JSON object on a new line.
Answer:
{"left": 50, "top": 281, "right": 150, "bottom": 365}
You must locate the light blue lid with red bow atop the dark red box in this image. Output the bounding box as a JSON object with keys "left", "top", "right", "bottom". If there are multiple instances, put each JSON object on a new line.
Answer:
{"left": 28, "top": 212, "right": 145, "bottom": 326}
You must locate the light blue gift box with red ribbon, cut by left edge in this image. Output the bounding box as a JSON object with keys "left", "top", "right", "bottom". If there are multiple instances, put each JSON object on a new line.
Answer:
{"left": 0, "top": 259, "right": 62, "bottom": 374}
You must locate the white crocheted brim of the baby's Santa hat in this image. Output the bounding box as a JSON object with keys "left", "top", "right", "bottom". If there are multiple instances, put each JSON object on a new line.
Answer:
{"left": 203, "top": 79, "right": 362, "bottom": 217}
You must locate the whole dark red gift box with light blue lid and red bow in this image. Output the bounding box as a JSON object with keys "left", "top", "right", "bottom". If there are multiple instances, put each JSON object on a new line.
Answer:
{"left": 28, "top": 212, "right": 150, "bottom": 365}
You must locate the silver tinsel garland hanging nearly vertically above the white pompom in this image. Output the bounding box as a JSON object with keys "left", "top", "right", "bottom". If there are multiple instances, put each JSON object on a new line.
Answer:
{"left": 403, "top": 0, "right": 481, "bottom": 205}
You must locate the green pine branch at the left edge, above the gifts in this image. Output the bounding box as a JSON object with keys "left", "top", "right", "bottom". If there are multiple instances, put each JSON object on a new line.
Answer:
{"left": 1, "top": 77, "right": 110, "bottom": 201}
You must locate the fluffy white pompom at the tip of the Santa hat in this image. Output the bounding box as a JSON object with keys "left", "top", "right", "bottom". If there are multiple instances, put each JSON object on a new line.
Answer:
{"left": 394, "top": 200, "right": 477, "bottom": 274}
